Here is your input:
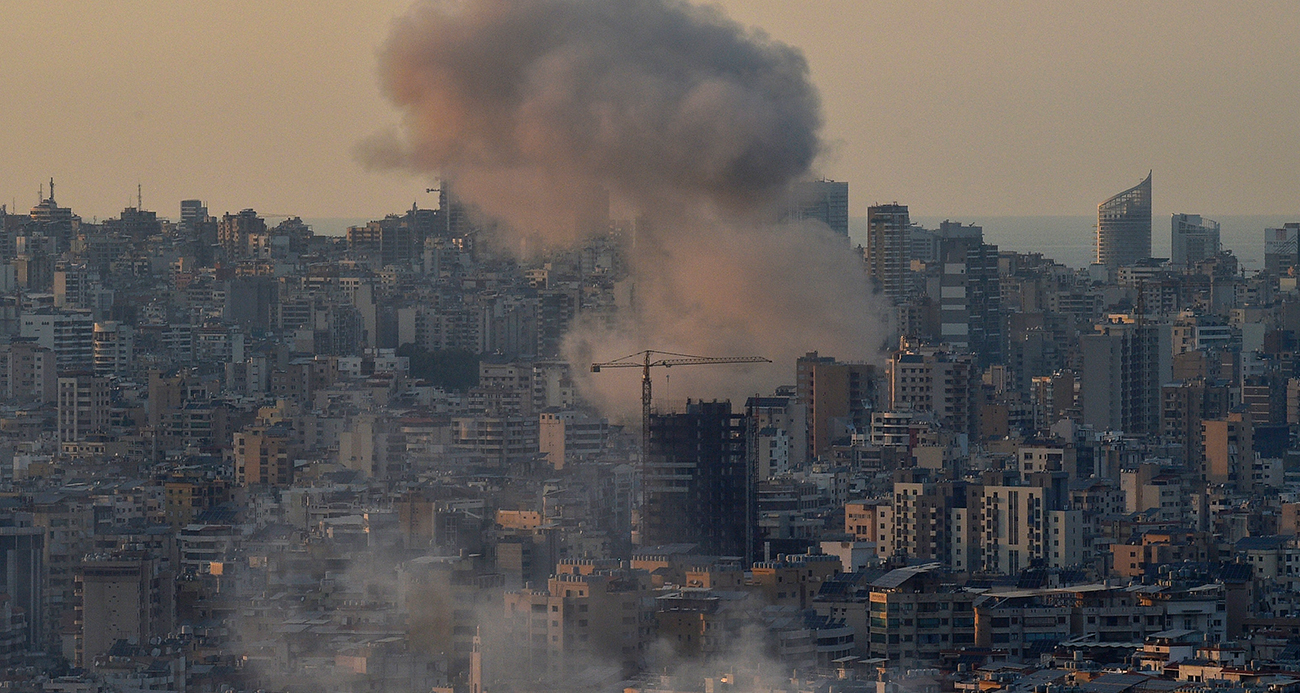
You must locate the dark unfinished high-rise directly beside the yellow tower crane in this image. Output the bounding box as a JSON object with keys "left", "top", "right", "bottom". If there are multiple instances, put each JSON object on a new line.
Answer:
{"left": 641, "top": 400, "right": 755, "bottom": 556}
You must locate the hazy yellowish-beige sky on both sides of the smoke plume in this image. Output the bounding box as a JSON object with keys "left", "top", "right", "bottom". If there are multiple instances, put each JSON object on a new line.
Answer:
{"left": 0, "top": 0, "right": 1300, "bottom": 226}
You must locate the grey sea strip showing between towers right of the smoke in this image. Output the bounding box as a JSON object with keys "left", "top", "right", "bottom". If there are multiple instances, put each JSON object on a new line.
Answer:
{"left": 849, "top": 215, "right": 1300, "bottom": 269}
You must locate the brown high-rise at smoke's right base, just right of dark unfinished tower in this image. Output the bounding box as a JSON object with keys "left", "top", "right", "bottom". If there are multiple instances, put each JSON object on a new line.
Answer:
{"left": 792, "top": 351, "right": 878, "bottom": 459}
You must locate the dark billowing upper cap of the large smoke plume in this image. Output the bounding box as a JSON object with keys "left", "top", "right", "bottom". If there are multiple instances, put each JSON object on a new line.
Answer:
{"left": 364, "top": 0, "right": 822, "bottom": 230}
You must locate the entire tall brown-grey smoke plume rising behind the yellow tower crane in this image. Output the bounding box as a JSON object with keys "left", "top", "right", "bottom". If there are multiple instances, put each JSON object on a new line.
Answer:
{"left": 360, "top": 0, "right": 884, "bottom": 411}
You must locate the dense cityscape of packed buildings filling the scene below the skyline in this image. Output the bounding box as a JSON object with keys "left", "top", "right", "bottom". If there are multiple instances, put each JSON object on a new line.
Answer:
{"left": 0, "top": 167, "right": 1300, "bottom": 693}
